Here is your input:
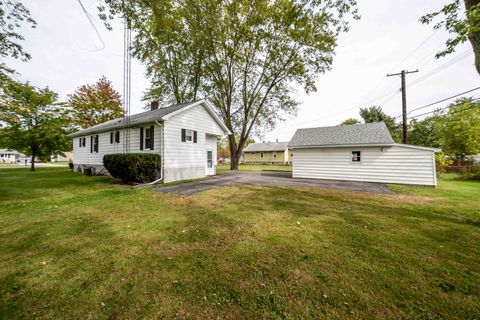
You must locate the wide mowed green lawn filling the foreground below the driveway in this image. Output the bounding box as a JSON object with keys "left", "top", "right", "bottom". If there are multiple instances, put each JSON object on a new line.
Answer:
{"left": 0, "top": 168, "right": 480, "bottom": 319}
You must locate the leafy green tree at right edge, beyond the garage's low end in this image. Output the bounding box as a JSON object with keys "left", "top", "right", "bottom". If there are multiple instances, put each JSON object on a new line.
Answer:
{"left": 440, "top": 98, "right": 480, "bottom": 158}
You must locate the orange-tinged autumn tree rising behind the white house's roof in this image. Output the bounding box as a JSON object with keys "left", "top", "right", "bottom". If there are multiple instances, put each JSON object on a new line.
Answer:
{"left": 68, "top": 77, "right": 123, "bottom": 128}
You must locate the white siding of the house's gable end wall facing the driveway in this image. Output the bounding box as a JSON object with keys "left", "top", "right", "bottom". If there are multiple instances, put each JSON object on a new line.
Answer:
{"left": 164, "top": 105, "right": 225, "bottom": 182}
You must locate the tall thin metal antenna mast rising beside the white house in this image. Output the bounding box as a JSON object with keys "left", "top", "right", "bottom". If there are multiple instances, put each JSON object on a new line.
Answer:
{"left": 123, "top": 19, "right": 132, "bottom": 153}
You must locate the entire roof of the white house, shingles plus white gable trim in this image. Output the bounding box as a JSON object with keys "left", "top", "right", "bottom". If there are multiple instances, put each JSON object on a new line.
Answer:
{"left": 69, "top": 100, "right": 229, "bottom": 138}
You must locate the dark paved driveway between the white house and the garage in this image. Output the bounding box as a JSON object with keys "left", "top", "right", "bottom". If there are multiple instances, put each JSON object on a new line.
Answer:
{"left": 155, "top": 171, "right": 392, "bottom": 196}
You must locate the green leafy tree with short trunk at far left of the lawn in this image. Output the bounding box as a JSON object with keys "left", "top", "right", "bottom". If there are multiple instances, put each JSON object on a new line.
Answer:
{"left": 0, "top": 81, "right": 72, "bottom": 171}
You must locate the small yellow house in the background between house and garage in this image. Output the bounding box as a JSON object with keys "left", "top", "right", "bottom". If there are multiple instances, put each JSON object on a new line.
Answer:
{"left": 243, "top": 141, "right": 292, "bottom": 165}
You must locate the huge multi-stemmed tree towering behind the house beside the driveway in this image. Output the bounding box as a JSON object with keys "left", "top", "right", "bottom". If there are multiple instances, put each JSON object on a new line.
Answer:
{"left": 100, "top": 0, "right": 358, "bottom": 169}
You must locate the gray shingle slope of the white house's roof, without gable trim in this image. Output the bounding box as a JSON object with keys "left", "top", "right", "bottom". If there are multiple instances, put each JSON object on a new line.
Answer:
{"left": 69, "top": 100, "right": 198, "bottom": 138}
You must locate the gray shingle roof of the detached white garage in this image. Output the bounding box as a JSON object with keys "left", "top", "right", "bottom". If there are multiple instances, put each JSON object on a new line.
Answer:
{"left": 288, "top": 122, "right": 394, "bottom": 147}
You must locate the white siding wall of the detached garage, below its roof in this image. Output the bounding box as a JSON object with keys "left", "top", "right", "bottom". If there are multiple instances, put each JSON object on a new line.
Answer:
{"left": 293, "top": 146, "right": 436, "bottom": 186}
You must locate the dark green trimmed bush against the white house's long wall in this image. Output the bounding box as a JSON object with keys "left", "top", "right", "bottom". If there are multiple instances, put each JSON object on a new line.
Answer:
{"left": 103, "top": 153, "right": 161, "bottom": 182}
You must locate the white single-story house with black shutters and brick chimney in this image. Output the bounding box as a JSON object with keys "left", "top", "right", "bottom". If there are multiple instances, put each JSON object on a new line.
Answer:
{"left": 70, "top": 100, "right": 229, "bottom": 182}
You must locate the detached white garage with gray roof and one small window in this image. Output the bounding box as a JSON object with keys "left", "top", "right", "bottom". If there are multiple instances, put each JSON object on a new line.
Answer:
{"left": 288, "top": 122, "right": 440, "bottom": 186}
